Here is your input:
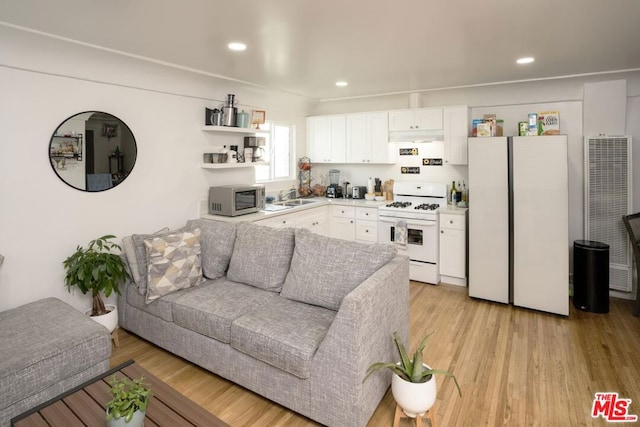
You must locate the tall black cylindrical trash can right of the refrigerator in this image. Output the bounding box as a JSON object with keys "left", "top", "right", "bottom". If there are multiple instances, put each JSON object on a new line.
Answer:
{"left": 573, "top": 240, "right": 609, "bottom": 313}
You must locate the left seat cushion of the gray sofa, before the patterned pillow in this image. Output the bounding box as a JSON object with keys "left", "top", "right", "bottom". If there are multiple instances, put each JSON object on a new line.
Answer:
{"left": 173, "top": 278, "right": 278, "bottom": 344}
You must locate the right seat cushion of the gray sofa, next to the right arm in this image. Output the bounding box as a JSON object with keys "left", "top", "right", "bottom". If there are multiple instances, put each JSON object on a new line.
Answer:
{"left": 231, "top": 296, "right": 336, "bottom": 378}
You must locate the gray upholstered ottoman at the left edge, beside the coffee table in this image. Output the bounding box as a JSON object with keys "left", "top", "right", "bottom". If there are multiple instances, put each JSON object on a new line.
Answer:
{"left": 0, "top": 298, "right": 111, "bottom": 427}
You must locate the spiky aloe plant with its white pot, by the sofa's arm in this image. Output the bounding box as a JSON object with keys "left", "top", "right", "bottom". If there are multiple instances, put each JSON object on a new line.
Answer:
{"left": 363, "top": 332, "right": 462, "bottom": 418}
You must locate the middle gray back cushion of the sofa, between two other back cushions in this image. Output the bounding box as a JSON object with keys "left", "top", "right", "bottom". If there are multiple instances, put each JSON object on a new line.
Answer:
{"left": 227, "top": 222, "right": 294, "bottom": 292}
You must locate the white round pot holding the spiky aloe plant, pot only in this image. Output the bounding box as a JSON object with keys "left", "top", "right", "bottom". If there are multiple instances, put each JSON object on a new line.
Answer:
{"left": 391, "top": 365, "right": 436, "bottom": 418}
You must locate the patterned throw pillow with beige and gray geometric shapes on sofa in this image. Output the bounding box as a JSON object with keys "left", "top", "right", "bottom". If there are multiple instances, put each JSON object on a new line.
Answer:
{"left": 144, "top": 228, "right": 204, "bottom": 304}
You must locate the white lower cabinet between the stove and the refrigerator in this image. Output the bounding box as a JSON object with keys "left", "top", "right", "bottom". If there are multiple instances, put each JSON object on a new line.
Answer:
{"left": 439, "top": 210, "right": 467, "bottom": 286}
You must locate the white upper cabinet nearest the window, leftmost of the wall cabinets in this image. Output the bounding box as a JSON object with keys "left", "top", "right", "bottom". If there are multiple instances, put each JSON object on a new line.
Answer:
{"left": 307, "top": 116, "right": 346, "bottom": 163}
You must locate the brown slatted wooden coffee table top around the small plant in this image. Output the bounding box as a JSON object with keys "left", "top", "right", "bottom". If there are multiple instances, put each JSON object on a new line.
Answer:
{"left": 11, "top": 360, "right": 228, "bottom": 427}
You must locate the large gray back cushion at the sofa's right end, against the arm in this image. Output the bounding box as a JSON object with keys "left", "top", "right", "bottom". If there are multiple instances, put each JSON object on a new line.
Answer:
{"left": 281, "top": 228, "right": 397, "bottom": 310}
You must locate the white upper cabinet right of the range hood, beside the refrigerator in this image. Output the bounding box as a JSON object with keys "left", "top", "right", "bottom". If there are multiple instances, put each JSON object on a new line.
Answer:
{"left": 443, "top": 105, "right": 469, "bottom": 165}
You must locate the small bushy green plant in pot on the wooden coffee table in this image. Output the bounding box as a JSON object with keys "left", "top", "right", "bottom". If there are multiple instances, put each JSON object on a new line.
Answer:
{"left": 107, "top": 376, "right": 153, "bottom": 427}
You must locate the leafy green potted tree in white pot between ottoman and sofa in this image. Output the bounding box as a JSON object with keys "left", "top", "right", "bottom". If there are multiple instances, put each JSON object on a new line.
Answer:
{"left": 62, "top": 235, "right": 129, "bottom": 332}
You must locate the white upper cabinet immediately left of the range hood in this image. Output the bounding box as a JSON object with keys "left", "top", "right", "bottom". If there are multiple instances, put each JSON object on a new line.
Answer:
{"left": 347, "top": 111, "right": 396, "bottom": 163}
